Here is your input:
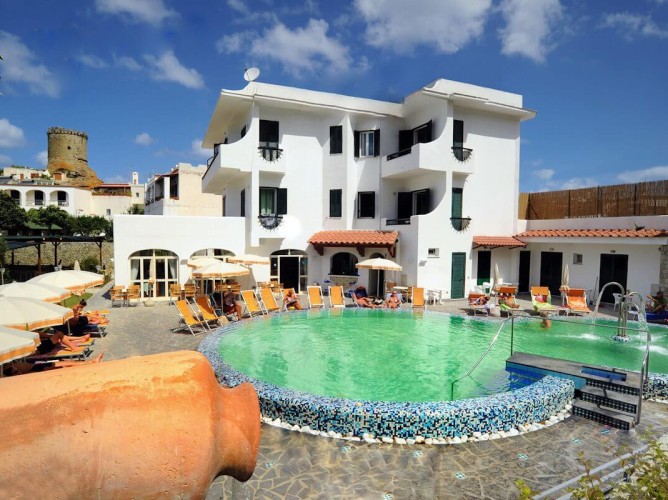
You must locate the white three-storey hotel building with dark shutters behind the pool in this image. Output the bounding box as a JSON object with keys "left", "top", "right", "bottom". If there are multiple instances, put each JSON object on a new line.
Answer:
{"left": 114, "top": 80, "right": 535, "bottom": 298}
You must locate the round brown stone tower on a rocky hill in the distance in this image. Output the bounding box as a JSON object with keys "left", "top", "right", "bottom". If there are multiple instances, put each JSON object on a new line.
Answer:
{"left": 46, "top": 127, "right": 102, "bottom": 188}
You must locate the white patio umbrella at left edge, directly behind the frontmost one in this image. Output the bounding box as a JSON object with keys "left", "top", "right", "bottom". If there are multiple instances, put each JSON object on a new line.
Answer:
{"left": 0, "top": 297, "right": 74, "bottom": 330}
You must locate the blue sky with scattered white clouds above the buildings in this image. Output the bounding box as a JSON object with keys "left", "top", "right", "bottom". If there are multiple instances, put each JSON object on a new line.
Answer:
{"left": 0, "top": 0, "right": 668, "bottom": 191}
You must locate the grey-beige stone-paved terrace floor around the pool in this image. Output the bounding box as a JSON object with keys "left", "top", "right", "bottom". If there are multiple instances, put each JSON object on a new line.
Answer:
{"left": 89, "top": 287, "right": 668, "bottom": 499}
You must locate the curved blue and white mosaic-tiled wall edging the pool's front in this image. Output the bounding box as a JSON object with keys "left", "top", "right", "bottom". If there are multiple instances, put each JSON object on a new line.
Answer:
{"left": 199, "top": 324, "right": 575, "bottom": 442}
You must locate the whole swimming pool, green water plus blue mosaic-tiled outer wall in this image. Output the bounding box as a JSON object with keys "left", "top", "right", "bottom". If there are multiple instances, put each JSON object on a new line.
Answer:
{"left": 200, "top": 309, "right": 668, "bottom": 444}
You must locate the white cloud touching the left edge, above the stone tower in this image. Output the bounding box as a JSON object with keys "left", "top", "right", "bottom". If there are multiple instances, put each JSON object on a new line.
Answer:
{"left": 0, "top": 31, "right": 60, "bottom": 97}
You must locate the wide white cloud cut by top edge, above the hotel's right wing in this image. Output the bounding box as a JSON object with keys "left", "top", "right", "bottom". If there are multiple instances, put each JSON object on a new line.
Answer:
{"left": 355, "top": 0, "right": 492, "bottom": 54}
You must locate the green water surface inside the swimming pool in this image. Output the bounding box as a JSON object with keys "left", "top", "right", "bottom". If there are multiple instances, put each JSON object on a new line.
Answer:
{"left": 219, "top": 309, "right": 668, "bottom": 402}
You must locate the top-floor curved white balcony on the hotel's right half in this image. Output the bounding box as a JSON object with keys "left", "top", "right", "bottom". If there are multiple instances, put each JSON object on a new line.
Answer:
{"left": 381, "top": 141, "right": 448, "bottom": 179}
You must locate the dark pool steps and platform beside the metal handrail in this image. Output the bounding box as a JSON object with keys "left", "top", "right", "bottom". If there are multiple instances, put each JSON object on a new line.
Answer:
{"left": 506, "top": 352, "right": 640, "bottom": 431}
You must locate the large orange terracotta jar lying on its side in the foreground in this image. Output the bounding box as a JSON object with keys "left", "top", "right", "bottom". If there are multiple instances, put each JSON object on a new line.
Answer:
{"left": 0, "top": 351, "right": 260, "bottom": 498}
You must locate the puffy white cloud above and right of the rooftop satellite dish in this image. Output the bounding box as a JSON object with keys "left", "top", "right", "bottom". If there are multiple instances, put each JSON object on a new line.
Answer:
{"left": 250, "top": 19, "right": 353, "bottom": 77}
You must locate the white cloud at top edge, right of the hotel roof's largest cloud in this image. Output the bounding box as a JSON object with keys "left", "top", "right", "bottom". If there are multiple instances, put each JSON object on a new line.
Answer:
{"left": 500, "top": 0, "right": 563, "bottom": 62}
